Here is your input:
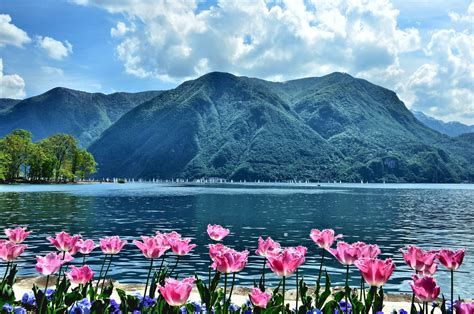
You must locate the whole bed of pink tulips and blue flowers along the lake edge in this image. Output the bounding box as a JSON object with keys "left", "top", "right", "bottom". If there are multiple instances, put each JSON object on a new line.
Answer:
{"left": 0, "top": 225, "right": 474, "bottom": 314}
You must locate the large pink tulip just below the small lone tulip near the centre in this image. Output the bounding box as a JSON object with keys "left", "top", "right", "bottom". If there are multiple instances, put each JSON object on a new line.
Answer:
{"left": 209, "top": 244, "right": 249, "bottom": 274}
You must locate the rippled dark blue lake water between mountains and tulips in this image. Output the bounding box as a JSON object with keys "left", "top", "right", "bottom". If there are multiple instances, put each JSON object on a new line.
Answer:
{"left": 0, "top": 183, "right": 474, "bottom": 297}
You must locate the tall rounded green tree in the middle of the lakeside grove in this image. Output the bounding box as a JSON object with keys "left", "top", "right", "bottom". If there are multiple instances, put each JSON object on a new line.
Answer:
{"left": 40, "top": 134, "right": 77, "bottom": 182}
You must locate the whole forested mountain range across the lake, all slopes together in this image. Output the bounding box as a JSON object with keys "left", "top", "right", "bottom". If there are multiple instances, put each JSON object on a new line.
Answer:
{"left": 0, "top": 72, "right": 474, "bottom": 182}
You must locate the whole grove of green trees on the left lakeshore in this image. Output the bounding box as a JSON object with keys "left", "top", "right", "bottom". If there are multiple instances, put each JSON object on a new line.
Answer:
{"left": 0, "top": 129, "right": 97, "bottom": 182}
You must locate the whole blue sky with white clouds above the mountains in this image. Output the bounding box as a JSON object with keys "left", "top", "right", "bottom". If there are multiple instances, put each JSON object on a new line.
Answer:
{"left": 0, "top": 0, "right": 474, "bottom": 124}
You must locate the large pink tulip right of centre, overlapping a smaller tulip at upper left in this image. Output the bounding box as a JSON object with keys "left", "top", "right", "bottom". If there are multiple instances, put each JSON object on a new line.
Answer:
{"left": 267, "top": 246, "right": 307, "bottom": 277}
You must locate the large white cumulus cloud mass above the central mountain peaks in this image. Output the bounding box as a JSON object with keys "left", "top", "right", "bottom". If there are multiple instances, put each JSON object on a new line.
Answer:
{"left": 72, "top": 0, "right": 420, "bottom": 81}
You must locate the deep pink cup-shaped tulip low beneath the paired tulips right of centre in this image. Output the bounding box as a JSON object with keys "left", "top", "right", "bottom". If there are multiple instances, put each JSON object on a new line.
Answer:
{"left": 354, "top": 258, "right": 395, "bottom": 287}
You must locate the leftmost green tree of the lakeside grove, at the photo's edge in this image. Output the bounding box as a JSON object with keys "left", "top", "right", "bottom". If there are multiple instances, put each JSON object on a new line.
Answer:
{"left": 0, "top": 129, "right": 33, "bottom": 180}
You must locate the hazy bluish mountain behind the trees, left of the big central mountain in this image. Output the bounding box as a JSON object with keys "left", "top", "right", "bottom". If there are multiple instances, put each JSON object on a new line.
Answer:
{"left": 0, "top": 87, "right": 160, "bottom": 147}
